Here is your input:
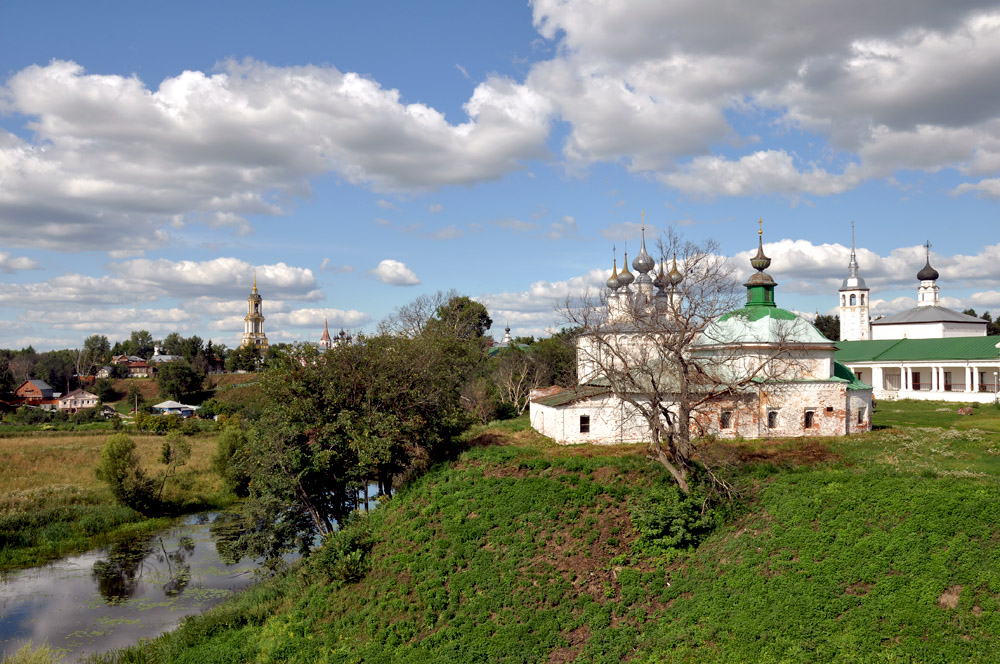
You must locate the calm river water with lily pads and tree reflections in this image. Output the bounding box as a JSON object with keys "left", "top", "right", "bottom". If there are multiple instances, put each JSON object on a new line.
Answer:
{"left": 0, "top": 514, "right": 257, "bottom": 662}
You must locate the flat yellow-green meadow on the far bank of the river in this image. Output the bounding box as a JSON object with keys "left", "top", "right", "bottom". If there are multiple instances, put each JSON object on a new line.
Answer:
{"left": 0, "top": 435, "right": 231, "bottom": 570}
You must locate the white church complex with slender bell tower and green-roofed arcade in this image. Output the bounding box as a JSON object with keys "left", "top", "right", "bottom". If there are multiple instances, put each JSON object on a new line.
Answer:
{"left": 836, "top": 240, "right": 1000, "bottom": 403}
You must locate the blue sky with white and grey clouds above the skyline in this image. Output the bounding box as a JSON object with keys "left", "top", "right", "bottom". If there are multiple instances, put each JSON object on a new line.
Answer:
{"left": 0, "top": 0, "right": 1000, "bottom": 349}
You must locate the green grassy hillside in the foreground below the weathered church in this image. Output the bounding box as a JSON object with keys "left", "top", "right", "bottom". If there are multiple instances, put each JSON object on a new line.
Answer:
{"left": 97, "top": 404, "right": 1000, "bottom": 662}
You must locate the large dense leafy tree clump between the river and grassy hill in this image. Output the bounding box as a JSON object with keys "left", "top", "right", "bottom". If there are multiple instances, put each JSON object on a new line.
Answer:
{"left": 232, "top": 335, "right": 468, "bottom": 556}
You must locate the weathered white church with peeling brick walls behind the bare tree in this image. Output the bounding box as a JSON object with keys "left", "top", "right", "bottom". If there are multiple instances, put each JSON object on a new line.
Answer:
{"left": 530, "top": 224, "right": 872, "bottom": 444}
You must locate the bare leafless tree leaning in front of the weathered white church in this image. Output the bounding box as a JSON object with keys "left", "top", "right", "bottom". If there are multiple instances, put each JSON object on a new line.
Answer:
{"left": 565, "top": 232, "right": 804, "bottom": 493}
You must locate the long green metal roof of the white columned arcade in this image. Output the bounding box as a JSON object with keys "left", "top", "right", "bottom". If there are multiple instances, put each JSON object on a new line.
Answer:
{"left": 834, "top": 337, "right": 1000, "bottom": 362}
